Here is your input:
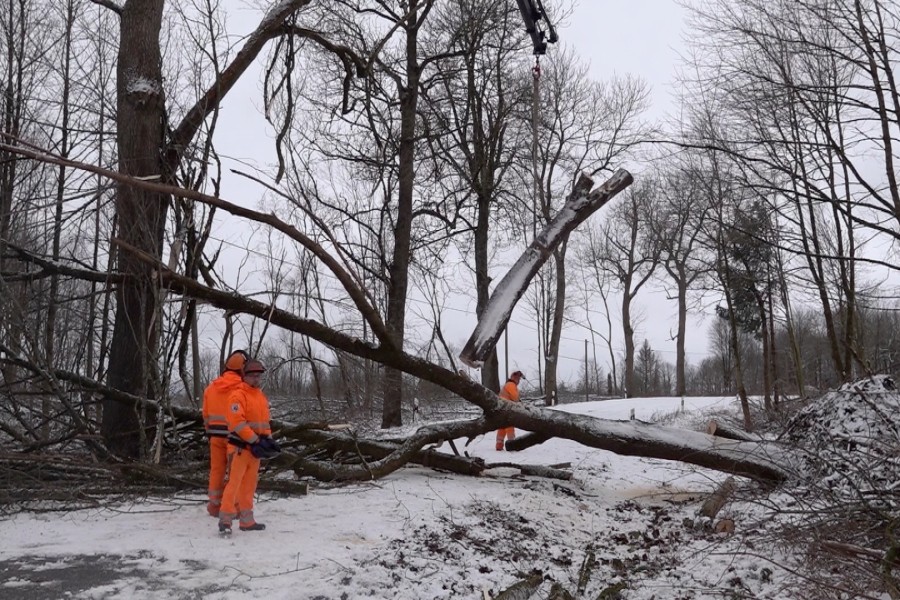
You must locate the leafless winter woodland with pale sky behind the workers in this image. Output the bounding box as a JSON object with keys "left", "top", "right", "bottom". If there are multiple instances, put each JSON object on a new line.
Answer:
{"left": 0, "top": 0, "right": 900, "bottom": 456}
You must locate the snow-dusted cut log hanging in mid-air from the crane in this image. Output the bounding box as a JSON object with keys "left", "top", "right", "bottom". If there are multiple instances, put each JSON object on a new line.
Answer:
{"left": 459, "top": 169, "right": 634, "bottom": 368}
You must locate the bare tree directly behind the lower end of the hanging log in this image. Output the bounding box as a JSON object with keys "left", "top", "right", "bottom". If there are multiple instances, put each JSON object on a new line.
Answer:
{"left": 423, "top": 0, "right": 528, "bottom": 391}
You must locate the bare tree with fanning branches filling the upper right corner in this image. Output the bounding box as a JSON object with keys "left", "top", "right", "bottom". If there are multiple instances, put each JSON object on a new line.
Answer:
{"left": 690, "top": 0, "right": 900, "bottom": 381}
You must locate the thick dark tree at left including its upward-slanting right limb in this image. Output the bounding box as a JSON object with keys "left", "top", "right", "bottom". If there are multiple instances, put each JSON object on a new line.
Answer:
{"left": 91, "top": 0, "right": 326, "bottom": 457}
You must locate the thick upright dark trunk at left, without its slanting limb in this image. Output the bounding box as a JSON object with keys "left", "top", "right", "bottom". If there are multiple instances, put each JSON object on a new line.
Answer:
{"left": 101, "top": 0, "right": 169, "bottom": 458}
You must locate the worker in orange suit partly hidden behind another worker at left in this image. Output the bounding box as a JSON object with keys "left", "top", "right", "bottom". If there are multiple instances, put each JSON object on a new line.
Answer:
{"left": 203, "top": 350, "right": 248, "bottom": 517}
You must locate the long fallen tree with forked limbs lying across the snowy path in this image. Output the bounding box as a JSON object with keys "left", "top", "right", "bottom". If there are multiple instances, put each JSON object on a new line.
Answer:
{"left": 0, "top": 316, "right": 789, "bottom": 484}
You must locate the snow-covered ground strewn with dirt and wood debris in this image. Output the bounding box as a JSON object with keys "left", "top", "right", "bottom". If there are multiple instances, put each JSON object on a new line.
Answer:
{"left": 0, "top": 398, "right": 844, "bottom": 600}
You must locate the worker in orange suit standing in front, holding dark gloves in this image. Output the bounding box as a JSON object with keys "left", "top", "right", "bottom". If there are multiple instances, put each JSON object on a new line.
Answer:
{"left": 219, "top": 359, "right": 281, "bottom": 534}
